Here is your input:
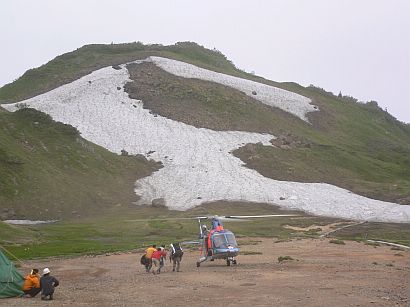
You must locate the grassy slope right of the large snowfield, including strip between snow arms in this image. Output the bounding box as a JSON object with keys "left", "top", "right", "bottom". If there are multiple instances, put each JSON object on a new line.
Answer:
{"left": 125, "top": 56, "right": 410, "bottom": 204}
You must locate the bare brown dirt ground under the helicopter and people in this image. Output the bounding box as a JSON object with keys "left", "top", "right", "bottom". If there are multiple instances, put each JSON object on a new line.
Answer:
{"left": 0, "top": 238, "right": 410, "bottom": 306}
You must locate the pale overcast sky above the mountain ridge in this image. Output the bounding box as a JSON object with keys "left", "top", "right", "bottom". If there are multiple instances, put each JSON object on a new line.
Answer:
{"left": 0, "top": 0, "right": 410, "bottom": 123}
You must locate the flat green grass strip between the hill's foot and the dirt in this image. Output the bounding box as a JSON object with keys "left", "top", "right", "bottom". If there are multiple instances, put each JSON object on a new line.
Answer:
{"left": 0, "top": 202, "right": 319, "bottom": 259}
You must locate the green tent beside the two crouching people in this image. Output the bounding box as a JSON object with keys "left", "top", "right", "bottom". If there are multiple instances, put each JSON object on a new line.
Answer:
{"left": 0, "top": 249, "right": 24, "bottom": 298}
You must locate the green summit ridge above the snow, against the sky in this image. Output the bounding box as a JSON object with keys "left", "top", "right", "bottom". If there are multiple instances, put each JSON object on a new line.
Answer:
{"left": 0, "top": 42, "right": 238, "bottom": 103}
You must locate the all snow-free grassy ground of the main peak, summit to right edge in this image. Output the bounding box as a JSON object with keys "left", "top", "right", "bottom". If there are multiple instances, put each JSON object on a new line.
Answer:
{"left": 0, "top": 43, "right": 410, "bottom": 221}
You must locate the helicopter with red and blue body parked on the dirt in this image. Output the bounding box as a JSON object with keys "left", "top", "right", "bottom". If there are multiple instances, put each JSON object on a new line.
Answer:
{"left": 193, "top": 214, "right": 296, "bottom": 267}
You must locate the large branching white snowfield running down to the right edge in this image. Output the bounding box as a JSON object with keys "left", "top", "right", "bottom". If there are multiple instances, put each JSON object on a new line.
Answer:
{"left": 3, "top": 62, "right": 410, "bottom": 222}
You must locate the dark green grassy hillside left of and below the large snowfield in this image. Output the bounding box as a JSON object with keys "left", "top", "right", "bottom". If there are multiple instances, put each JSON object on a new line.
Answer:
{"left": 0, "top": 109, "right": 158, "bottom": 219}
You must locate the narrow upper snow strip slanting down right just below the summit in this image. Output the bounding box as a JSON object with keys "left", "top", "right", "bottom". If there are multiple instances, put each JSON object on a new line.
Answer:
{"left": 149, "top": 56, "right": 319, "bottom": 122}
